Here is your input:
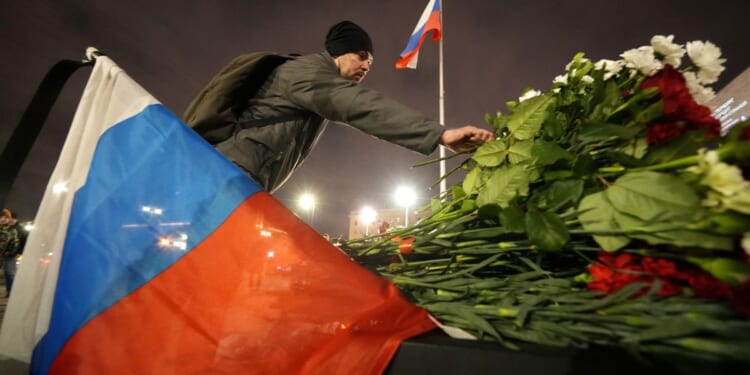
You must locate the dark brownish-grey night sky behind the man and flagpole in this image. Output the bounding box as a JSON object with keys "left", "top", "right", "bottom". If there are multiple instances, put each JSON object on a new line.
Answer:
{"left": 0, "top": 0, "right": 750, "bottom": 236}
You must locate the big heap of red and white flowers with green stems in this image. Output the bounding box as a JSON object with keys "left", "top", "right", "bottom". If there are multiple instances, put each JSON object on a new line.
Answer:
{"left": 342, "top": 35, "right": 750, "bottom": 362}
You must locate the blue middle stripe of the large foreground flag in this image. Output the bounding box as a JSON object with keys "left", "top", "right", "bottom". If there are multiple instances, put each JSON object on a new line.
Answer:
{"left": 32, "top": 104, "right": 261, "bottom": 374}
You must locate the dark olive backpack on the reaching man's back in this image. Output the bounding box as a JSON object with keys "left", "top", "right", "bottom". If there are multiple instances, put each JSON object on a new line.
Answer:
{"left": 182, "top": 52, "right": 294, "bottom": 144}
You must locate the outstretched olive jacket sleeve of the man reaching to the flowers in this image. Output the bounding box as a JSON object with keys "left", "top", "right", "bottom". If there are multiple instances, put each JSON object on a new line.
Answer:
{"left": 286, "top": 56, "right": 445, "bottom": 155}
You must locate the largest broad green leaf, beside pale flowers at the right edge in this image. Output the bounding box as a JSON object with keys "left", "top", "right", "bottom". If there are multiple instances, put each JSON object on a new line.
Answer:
{"left": 604, "top": 171, "right": 700, "bottom": 221}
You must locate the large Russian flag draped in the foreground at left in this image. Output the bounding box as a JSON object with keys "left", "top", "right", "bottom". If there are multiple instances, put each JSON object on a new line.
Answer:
{"left": 0, "top": 50, "right": 434, "bottom": 375}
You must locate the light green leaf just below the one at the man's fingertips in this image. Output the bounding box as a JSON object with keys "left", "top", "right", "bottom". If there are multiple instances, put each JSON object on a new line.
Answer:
{"left": 477, "top": 166, "right": 529, "bottom": 207}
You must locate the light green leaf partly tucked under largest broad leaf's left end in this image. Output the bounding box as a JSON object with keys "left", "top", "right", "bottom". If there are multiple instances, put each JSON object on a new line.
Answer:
{"left": 578, "top": 192, "right": 630, "bottom": 252}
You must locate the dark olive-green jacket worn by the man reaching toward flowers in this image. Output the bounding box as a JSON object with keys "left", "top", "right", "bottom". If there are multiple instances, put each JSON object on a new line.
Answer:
{"left": 215, "top": 53, "right": 444, "bottom": 191}
